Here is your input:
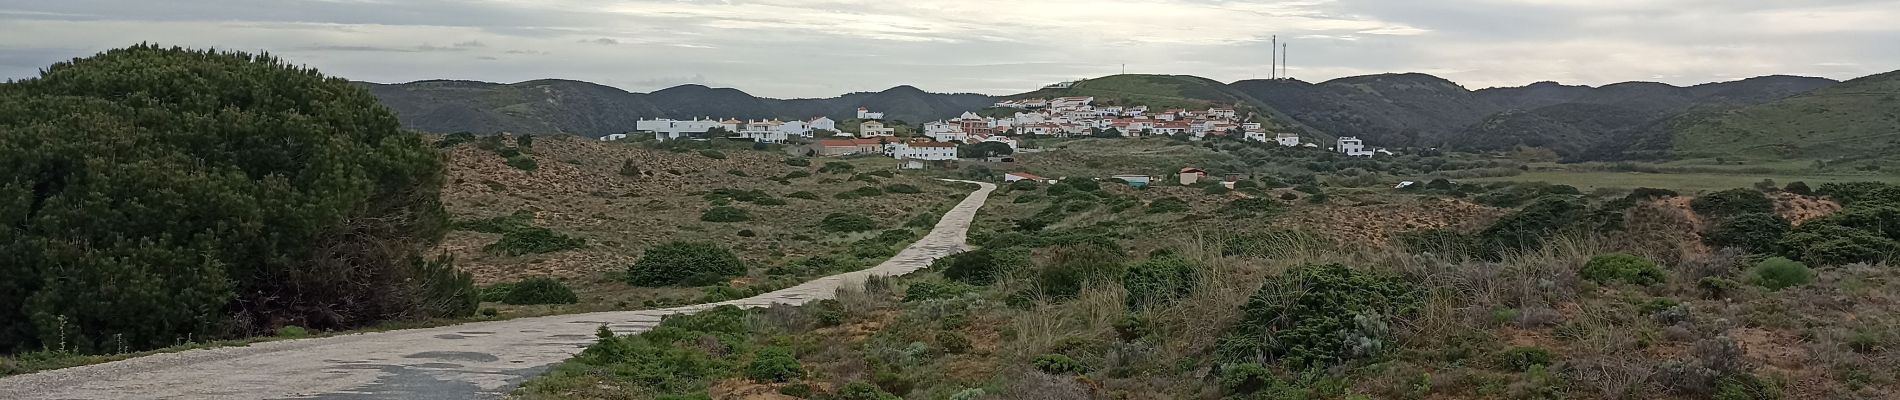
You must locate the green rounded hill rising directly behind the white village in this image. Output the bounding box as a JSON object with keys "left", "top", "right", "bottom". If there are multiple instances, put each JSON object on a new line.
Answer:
{"left": 1003, "top": 74, "right": 1326, "bottom": 135}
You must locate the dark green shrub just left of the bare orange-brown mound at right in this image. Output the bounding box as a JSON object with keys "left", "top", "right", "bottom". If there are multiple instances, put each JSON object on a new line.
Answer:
{"left": 1473, "top": 195, "right": 1587, "bottom": 260}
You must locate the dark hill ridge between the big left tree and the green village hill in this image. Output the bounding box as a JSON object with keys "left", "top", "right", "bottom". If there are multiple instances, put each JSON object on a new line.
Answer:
{"left": 357, "top": 80, "right": 996, "bottom": 136}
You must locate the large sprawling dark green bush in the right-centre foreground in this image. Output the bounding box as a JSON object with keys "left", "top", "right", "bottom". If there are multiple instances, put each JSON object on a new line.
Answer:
{"left": 1218, "top": 264, "right": 1419, "bottom": 370}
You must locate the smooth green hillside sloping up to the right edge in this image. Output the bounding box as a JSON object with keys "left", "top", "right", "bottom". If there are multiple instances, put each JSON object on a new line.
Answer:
{"left": 1664, "top": 70, "right": 1900, "bottom": 159}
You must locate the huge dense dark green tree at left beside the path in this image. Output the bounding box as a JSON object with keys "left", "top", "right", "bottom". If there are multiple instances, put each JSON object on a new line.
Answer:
{"left": 0, "top": 45, "right": 477, "bottom": 353}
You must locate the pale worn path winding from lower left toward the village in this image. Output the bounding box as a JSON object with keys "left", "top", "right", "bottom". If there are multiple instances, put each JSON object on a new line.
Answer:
{"left": 0, "top": 182, "right": 996, "bottom": 400}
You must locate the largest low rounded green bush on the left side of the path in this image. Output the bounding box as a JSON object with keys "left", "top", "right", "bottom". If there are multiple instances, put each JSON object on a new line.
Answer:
{"left": 627, "top": 241, "right": 745, "bottom": 286}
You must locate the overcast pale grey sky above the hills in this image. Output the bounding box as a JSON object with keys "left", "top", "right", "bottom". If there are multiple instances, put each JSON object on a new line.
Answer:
{"left": 0, "top": 0, "right": 1900, "bottom": 97}
